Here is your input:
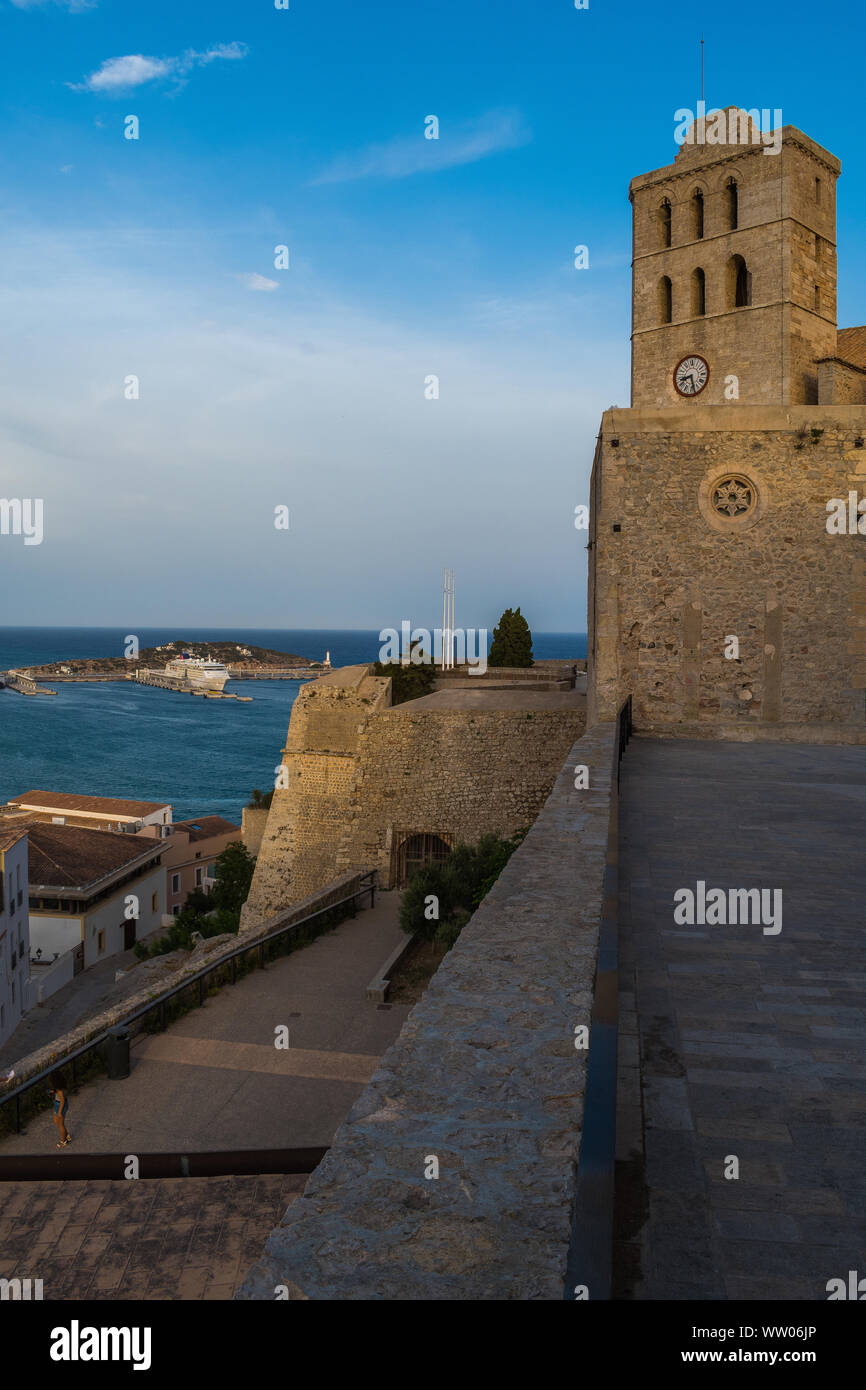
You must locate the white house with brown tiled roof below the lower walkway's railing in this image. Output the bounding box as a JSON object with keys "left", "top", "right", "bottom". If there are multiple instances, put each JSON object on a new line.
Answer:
{"left": 26, "top": 803, "right": 165, "bottom": 973}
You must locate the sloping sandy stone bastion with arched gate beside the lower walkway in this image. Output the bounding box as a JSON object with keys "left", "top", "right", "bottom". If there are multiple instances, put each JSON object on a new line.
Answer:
{"left": 242, "top": 667, "right": 584, "bottom": 930}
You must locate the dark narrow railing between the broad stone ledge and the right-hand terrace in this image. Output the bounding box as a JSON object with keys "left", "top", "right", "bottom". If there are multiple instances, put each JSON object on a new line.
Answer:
{"left": 563, "top": 695, "right": 631, "bottom": 1301}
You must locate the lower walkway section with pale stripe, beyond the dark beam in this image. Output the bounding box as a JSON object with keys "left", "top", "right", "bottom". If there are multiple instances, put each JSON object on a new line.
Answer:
{"left": 0, "top": 892, "right": 409, "bottom": 1154}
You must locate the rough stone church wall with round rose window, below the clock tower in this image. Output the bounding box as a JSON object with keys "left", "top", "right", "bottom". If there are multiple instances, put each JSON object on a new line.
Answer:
{"left": 589, "top": 406, "right": 866, "bottom": 742}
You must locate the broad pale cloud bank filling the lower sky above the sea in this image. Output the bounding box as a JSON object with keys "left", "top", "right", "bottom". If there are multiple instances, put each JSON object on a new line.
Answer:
{"left": 0, "top": 218, "right": 608, "bottom": 632}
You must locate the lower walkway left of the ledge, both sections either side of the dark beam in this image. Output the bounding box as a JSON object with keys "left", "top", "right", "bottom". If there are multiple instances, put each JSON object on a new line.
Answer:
{"left": 0, "top": 892, "right": 409, "bottom": 1300}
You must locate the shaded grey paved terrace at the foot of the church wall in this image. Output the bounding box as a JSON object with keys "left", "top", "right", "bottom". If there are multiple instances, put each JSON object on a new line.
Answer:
{"left": 616, "top": 738, "right": 866, "bottom": 1300}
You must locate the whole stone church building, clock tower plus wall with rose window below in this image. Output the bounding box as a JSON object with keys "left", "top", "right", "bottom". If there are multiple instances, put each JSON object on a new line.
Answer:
{"left": 587, "top": 107, "right": 866, "bottom": 744}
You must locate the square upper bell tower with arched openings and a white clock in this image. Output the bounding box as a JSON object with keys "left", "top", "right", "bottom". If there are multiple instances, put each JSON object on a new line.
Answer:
{"left": 630, "top": 107, "right": 841, "bottom": 406}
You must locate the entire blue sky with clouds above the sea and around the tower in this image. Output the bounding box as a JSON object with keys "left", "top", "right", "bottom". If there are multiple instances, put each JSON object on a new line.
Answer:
{"left": 0, "top": 0, "right": 866, "bottom": 631}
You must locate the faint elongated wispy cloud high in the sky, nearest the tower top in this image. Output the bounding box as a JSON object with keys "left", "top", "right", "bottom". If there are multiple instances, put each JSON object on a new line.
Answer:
{"left": 313, "top": 111, "right": 532, "bottom": 183}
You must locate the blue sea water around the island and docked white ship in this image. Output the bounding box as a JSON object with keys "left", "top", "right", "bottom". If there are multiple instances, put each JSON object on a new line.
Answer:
{"left": 0, "top": 627, "right": 587, "bottom": 824}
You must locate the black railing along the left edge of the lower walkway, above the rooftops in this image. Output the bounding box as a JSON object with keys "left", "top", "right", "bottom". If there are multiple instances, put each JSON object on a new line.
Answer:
{"left": 0, "top": 870, "right": 375, "bottom": 1133}
